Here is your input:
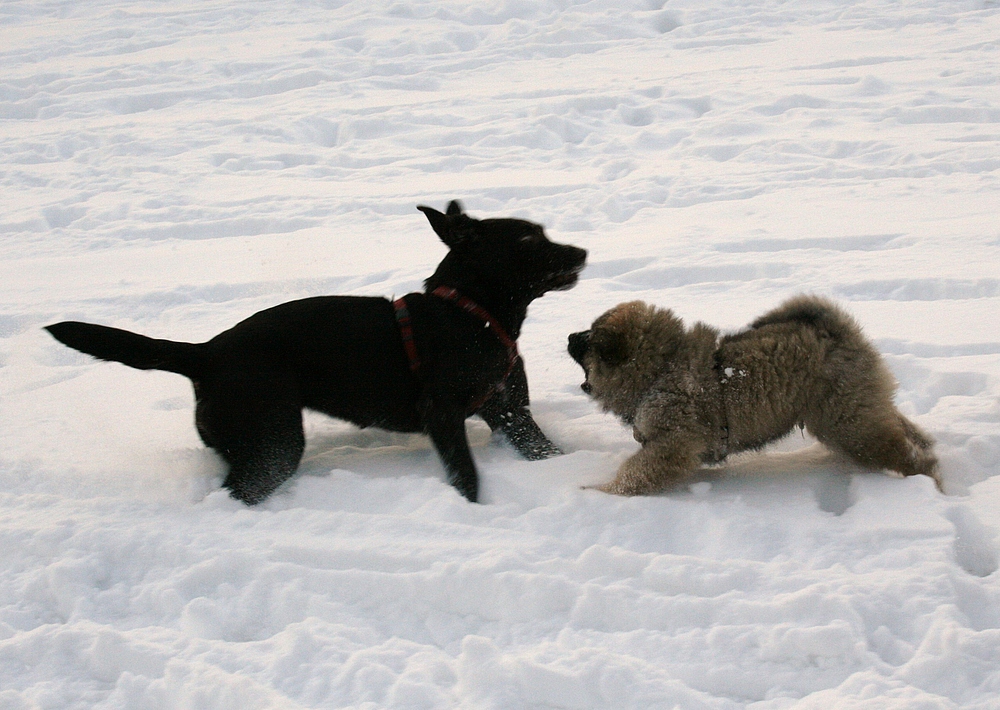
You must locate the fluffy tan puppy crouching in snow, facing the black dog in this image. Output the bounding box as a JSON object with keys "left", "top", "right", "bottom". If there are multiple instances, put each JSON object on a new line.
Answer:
{"left": 569, "top": 296, "right": 941, "bottom": 495}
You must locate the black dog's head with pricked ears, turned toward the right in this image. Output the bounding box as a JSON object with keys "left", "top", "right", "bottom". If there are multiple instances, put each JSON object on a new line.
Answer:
{"left": 417, "top": 200, "right": 587, "bottom": 307}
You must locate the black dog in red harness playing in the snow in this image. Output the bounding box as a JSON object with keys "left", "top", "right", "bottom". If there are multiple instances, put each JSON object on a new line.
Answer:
{"left": 47, "top": 201, "right": 587, "bottom": 505}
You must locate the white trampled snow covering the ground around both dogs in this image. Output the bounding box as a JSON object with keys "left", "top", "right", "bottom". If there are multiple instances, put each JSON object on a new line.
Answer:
{"left": 0, "top": 0, "right": 1000, "bottom": 710}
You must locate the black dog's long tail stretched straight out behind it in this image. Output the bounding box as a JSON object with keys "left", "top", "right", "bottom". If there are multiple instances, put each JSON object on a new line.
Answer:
{"left": 45, "top": 321, "right": 205, "bottom": 379}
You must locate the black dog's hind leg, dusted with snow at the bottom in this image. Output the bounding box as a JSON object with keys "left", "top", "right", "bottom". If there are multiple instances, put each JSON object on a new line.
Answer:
{"left": 196, "top": 381, "right": 305, "bottom": 505}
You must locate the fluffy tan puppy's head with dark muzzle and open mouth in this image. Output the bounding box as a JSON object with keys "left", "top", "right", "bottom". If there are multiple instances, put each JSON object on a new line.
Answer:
{"left": 567, "top": 301, "right": 684, "bottom": 421}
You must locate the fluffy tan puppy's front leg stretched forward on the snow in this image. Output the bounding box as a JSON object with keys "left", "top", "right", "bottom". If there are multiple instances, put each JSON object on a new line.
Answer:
{"left": 595, "top": 439, "right": 705, "bottom": 496}
